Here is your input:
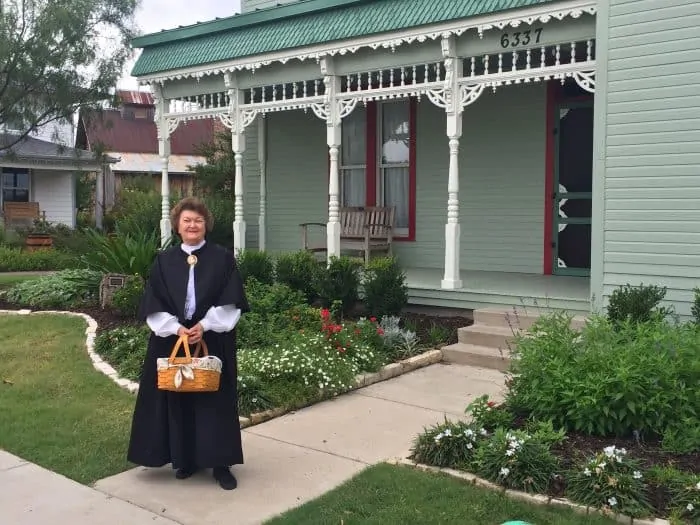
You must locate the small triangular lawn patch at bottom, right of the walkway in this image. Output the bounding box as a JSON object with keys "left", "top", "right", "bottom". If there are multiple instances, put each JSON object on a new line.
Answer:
{"left": 266, "top": 464, "right": 615, "bottom": 525}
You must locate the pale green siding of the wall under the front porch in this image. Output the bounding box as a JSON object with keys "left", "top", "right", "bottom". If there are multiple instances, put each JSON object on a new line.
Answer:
{"left": 267, "top": 84, "right": 546, "bottom": 274}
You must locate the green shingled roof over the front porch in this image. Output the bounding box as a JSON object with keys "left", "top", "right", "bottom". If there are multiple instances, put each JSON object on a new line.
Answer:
{"left": 132, "top": 0, "right": 554, "bottom": 76}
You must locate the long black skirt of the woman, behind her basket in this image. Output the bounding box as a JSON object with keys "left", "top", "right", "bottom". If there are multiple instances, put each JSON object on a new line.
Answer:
{"left": 127, "top": 332, "right": 243, "bottom": 469}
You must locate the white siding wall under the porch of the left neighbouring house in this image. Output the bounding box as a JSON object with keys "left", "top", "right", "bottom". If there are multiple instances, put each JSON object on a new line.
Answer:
{"left": 31, "top": 170, "right": 75, "bottom": 228}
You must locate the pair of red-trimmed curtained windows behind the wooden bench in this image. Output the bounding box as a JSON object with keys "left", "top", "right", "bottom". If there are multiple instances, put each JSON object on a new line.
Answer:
{"left": 340, "top": 99, "right": 416, "bottom": 240}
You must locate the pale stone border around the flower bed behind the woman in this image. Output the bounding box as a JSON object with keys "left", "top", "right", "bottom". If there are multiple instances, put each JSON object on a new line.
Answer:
{"left": 0, "top": 309, "right": 443, "bottom": 428}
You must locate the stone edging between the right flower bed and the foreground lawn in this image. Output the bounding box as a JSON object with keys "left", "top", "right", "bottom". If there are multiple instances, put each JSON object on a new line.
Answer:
{"left": 391, "top": 457, "right": 671, "bottom": 525}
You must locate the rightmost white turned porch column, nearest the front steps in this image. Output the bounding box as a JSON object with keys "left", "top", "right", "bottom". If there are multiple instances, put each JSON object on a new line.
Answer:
{"left": 441, "top": 36, "right": 462, "bottom": 290}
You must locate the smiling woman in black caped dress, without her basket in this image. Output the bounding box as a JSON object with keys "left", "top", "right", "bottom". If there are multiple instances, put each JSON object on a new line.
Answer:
{"left": 127, "top": 197, "right": 250, "bottom": 490}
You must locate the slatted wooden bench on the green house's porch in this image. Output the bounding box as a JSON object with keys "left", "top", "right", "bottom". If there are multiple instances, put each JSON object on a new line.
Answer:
{"left": 299, "top": 206, "right": 396, "bottom": 264}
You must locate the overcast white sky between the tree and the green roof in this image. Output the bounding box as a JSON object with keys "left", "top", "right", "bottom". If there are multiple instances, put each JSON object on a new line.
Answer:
{"left": 118, "top": 0, "right": 241, "bottom": 89}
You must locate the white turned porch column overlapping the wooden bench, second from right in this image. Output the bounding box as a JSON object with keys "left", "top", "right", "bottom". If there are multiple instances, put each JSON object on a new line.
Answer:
{"left": 321, "top": 58, "right": 342, "bottom": 264}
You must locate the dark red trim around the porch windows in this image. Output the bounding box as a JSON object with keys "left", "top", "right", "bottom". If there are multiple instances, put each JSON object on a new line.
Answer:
{"left": 365, "top": 97, "right": 418, "bottom": 242}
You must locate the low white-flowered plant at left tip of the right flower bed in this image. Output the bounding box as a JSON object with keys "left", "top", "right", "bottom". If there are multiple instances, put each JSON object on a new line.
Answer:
{"left": 410, "top": 419, "right": 488, "bottom": 470}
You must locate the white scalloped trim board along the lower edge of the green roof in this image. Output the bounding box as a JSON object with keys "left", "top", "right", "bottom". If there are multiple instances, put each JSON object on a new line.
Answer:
{"left": 139, "top": 0, "right": 597, "bottom": 84}
